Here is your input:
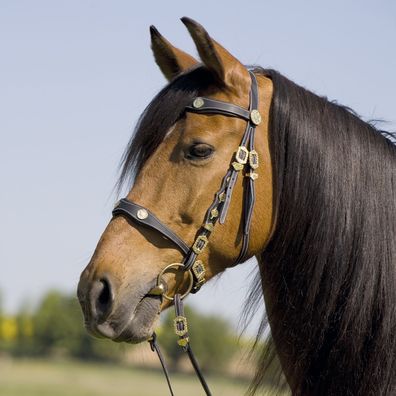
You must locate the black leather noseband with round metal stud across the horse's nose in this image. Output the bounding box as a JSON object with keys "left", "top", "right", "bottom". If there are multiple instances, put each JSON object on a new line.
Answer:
{"left": 113, "top": 198, "right": 190, "bottom": 254}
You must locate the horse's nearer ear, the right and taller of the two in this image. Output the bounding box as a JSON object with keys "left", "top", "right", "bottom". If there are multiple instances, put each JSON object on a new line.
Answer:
{"left": 181, "top": 17, "right": 250, "bottom": 90}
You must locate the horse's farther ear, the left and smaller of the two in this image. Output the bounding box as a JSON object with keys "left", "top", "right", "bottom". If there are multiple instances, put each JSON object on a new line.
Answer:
{"left": 150, "top": 26, "right": 198, "bottom": 81}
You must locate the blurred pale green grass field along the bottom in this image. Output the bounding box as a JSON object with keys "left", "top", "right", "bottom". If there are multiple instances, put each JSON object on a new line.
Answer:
{"left": 0, "top": 359, "right": 254, "bottom": 396}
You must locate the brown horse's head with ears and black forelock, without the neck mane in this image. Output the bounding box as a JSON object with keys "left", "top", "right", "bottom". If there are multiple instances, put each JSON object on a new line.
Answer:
{"left": 78, "top": 18, "right": 272, "bottom": 343}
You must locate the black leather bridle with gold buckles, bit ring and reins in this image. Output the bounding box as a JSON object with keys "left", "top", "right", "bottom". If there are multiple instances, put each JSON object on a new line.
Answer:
{"left": 113, "top": 71, "right": 262, "bottom": 395}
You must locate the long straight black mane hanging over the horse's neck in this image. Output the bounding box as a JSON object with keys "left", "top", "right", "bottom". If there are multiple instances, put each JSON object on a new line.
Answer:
{"left": 248, "top": 69, "right": 396, "bottom": 396}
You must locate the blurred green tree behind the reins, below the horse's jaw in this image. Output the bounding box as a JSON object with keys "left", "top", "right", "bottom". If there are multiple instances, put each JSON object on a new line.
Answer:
{"left": 159, "top": 307, "right": 237, "bottom": 372}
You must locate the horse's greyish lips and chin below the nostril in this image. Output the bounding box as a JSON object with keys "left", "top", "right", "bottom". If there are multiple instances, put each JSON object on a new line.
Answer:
{"left": 88, "top": 295, "right": 161, "bottom": 344}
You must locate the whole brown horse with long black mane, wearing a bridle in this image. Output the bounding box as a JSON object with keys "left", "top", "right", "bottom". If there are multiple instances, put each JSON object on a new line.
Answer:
{"left": 78, "top": 17, "right": 396, "bottom": 396}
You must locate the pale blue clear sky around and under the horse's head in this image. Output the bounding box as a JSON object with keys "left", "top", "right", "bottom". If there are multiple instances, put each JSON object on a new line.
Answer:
{"left": 0, "top": 0, "right": 396, "bottom": 334}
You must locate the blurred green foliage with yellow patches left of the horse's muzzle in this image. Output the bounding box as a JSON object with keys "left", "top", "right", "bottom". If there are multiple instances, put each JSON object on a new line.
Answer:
{"left": 0, "top": 291, "right": 122, "bottom": 361}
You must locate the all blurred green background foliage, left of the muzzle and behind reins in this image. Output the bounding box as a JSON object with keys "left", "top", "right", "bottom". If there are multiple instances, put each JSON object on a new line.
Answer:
{"left": 0, "top": 290, "right": 237, "bottom": 372}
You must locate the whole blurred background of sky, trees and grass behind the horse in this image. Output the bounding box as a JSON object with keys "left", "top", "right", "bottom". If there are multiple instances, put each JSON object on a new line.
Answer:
{"left": 0, "top": 0, "right": 396, "bottom": 396}
